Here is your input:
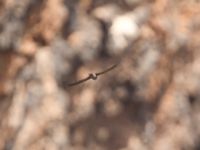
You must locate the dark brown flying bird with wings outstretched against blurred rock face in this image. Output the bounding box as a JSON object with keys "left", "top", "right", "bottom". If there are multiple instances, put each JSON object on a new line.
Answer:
{"left": 68, "top": 64, "right": 118, "bottom": 86}
